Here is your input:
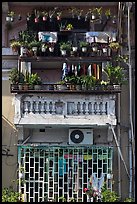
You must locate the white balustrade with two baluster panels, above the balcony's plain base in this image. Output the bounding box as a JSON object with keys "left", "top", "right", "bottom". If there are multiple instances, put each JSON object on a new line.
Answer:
{"left": 15, "top": 93, "right": 115, "bottom": 125}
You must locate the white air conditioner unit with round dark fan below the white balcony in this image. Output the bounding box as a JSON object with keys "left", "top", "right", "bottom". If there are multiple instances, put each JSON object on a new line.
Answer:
{"left": 69, "top": 129, "right": 93, "bottom": 145}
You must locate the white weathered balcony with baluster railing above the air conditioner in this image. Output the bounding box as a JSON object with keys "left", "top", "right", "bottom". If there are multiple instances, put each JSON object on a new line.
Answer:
{"left": 14, "top": 91, "right": 116, "bottom": 127}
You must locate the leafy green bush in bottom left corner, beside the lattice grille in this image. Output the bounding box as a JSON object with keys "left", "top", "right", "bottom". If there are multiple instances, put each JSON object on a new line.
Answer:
{"left": 2, "top": 186, "right": 21, "bottom": 202}
